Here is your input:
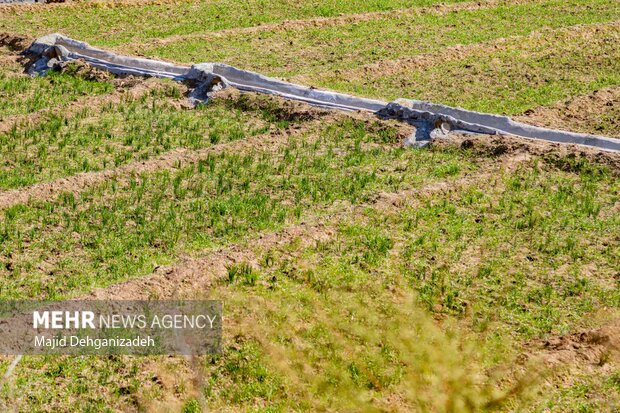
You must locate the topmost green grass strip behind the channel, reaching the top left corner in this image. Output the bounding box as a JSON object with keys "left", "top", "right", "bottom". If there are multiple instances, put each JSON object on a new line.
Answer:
{"left": 0, "top": 0, "right": 472, "bottom": 46}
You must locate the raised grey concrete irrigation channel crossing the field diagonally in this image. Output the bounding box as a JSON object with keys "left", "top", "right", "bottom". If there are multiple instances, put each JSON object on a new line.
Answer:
{"left": 25, "top": 33, "right": 620, "bottom": 151}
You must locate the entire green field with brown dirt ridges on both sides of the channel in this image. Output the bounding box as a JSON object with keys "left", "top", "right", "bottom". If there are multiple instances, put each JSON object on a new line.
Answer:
{"left": 0, "top": 0, "right": 620, "bottom": 413}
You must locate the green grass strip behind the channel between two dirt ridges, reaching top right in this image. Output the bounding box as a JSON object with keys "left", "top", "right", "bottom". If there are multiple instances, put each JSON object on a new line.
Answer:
{"left": 134, "top": 0, "right": 620, "bottom": 78}
